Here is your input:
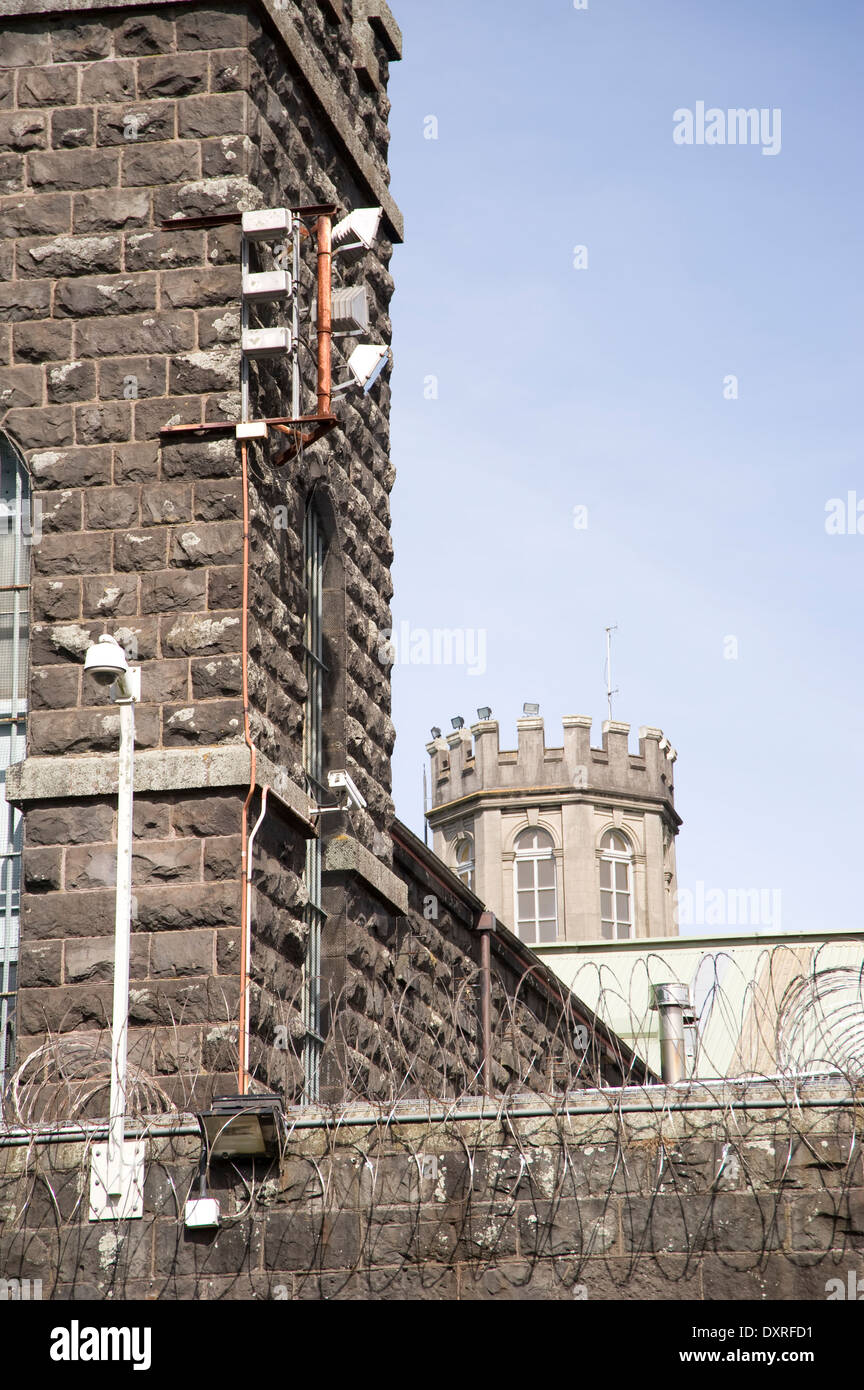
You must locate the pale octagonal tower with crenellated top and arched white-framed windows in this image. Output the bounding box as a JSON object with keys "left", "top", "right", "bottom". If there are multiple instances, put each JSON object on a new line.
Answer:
{"left": 426, "top": 714, "right": 681, "bottom": 945}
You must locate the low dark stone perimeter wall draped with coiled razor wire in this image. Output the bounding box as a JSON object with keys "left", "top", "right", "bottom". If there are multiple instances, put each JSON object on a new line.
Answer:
{"left": 0, "top": 1079, "right": 864, "bottom": 1302}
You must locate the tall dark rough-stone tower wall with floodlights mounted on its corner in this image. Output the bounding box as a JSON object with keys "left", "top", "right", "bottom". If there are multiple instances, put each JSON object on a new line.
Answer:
{"left": 0, "top": 0, "right": 401, "bottom": 1111}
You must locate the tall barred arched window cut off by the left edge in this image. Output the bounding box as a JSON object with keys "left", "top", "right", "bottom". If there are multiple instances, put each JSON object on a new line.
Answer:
{"left": 0, "top": 434, "right": 31, "bottom": 1095}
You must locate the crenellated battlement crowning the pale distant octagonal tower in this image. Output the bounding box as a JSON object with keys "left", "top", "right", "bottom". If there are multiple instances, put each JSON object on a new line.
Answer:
{"left": 426, "top": 714, "right": 678, "bottom": 810}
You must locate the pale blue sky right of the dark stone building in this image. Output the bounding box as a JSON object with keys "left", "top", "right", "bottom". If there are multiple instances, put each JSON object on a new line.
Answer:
{"left": 390, "top": 0, "right": 864, "bottom": 930}
